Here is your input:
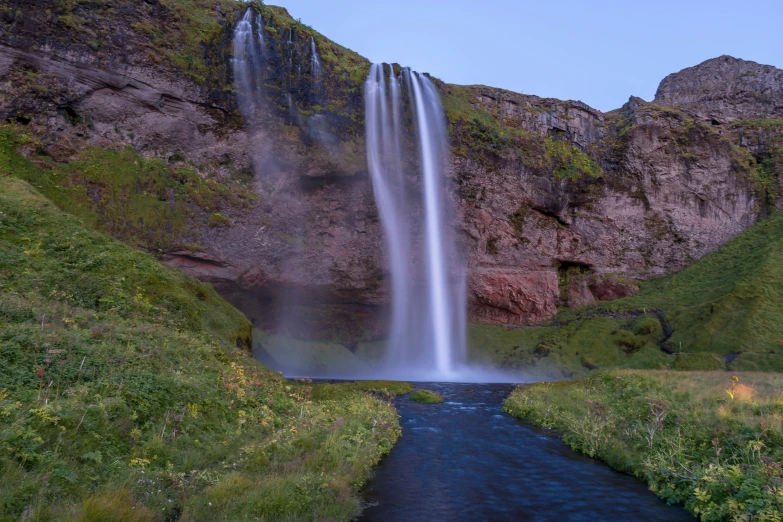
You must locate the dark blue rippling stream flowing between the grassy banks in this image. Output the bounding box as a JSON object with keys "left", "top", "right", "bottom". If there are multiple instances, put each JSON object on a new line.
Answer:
{"left": 360, "top": 383, "right": 694, "bottom": 522}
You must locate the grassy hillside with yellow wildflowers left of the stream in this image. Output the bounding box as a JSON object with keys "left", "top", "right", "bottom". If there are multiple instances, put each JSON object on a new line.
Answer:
{"left": 0, "top": 176, "right": 399, "bottom": 521}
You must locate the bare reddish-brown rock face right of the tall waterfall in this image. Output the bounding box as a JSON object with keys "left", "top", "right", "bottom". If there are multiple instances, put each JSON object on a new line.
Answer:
{"left": 455, "top": 90, "right": 760, "bottom": 322}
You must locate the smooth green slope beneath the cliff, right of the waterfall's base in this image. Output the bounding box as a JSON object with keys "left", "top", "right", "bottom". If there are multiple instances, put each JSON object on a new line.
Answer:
{"left": 471, "top": 212, "right": 783, "bottom": 377}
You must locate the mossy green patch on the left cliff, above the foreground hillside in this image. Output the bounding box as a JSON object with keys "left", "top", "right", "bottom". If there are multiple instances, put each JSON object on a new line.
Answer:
{"left": 0, "top": 127, "right": 254, "bottom": 251}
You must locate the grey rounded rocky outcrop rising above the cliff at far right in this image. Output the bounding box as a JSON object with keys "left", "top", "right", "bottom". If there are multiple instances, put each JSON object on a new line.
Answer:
{"left": 654, "top": 56, "right": 783, "bottom": 124}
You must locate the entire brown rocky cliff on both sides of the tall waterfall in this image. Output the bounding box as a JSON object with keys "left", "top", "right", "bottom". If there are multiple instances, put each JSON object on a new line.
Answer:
{"left": 0, "top": 0, "right": 783, "bottom": 342}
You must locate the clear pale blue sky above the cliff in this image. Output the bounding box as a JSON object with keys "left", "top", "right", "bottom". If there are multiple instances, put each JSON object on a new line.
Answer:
{"left": 267, "top": 0, "right": 783, "bottom": 111}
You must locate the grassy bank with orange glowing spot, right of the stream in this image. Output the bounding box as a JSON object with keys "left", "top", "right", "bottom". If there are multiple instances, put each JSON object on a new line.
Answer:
{"left": 506, "top": 370, "right": 783, "bottom": 522}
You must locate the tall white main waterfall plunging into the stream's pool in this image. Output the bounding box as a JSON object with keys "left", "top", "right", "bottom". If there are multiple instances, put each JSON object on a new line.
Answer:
{"left": 365, "top": 64, "right": 466, "bottom": 377}
